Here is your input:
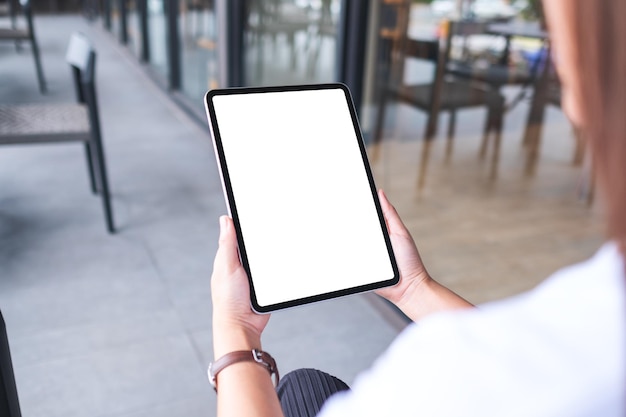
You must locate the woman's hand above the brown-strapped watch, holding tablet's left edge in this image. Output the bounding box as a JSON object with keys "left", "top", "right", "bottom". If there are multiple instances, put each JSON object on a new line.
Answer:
{"left": 211, "top": 216, "right": 270, "bottom": 358}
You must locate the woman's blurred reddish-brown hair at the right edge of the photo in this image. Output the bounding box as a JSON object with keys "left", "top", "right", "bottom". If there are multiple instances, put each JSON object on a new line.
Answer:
{"left": 557, "top": 0, "right": 626, "bottom": 253}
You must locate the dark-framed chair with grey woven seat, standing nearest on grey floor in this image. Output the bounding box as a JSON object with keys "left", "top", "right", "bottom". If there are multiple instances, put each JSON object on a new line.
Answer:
{"left": 0, "top": 33, "right": 115, "bottom": 233}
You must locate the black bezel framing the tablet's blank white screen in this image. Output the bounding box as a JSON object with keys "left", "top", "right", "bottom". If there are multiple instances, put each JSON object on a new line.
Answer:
{"left": 204, "top": 83, "right": 400, "bottom": 313}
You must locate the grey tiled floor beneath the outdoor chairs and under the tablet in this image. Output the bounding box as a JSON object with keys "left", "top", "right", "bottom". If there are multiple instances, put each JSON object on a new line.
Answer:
{"left": 0, "top": 16, "right": 398, "bottom": 417}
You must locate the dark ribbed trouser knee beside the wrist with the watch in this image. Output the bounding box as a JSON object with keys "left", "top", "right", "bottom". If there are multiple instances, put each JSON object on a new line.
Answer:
{"left": 276, "top": 368, "right": 350, "bottom": 417}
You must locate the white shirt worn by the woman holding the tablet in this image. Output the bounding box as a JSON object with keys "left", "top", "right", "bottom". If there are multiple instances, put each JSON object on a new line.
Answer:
{"left": 319, "top": 243, "right": 626, "bottom": 417}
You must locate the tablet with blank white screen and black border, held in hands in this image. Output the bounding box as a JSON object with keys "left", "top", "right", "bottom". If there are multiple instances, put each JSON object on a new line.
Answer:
{"left": 205, "top": 84, "right": 399, "bottom": 313}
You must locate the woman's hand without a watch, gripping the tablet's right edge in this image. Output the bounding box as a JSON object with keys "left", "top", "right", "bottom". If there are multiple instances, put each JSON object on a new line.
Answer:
{"left": 376, "top": 190, "right": 472, "bottom": 321}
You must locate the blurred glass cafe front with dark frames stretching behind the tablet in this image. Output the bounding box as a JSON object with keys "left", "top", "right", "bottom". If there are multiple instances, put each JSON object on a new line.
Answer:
{"left": 2, "top": 0, "right": 602, "bottom": 303}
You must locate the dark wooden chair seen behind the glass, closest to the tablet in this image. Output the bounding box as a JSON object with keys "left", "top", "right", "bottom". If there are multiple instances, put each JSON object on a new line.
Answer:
{"left": 374, "top": 24, "right": 504, "bottom": 188}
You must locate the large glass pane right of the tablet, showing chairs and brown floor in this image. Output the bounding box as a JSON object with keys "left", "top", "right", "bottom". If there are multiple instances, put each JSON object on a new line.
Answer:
{"left": 366, "top": 0, "right": 600, "bottom": 303}
